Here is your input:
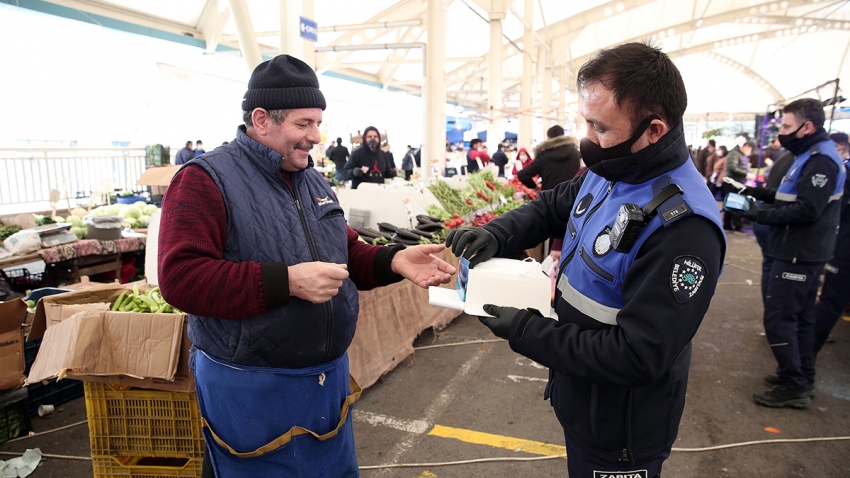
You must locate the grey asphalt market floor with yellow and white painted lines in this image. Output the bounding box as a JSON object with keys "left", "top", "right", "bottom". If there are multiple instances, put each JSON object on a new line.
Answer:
{"left": 0, "top": 230, "right": 850, "bottom": 478}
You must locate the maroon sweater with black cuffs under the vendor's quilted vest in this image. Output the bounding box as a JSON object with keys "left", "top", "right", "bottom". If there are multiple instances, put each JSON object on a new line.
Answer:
{"left": 159, "top": 165, "right": 402, "bottom": 319}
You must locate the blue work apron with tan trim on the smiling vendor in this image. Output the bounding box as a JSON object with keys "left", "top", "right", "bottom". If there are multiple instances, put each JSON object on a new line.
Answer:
{"left": 193, "top": 349, "right": 360, "bottom": 478}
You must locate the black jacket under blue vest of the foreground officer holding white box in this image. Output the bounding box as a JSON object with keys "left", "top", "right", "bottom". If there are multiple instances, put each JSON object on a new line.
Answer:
{"left": 484, "top": 126, "right": 725, "bottom": 461}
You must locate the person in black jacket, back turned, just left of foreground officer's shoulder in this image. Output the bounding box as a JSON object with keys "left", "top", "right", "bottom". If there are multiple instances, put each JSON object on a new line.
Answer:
{"left": 517, "top": 125, "right": 580, "bottom": 191}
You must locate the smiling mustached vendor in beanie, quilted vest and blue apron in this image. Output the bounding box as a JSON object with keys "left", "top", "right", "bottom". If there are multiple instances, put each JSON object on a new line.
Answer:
{"left": 159, "top": 55, "right": 455, "bottom": 478}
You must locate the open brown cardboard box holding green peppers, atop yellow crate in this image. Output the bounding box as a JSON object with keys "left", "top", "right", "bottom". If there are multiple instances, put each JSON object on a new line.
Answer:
{"left": 27, "top": 284, "right": 195, "bottom": 392}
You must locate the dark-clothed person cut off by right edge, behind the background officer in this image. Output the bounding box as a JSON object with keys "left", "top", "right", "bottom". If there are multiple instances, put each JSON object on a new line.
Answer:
{"left": 814, "top": 133, "right": 850, "bottom": 362}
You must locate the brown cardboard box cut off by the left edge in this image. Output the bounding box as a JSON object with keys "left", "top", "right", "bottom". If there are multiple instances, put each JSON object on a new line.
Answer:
{"left": 0, "top": 299, "right": 27, "bottom": 390}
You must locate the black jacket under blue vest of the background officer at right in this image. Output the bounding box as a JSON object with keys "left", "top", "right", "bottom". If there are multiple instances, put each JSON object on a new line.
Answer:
{"left": 747, "top": 128, "right": 847, "bottom": 263}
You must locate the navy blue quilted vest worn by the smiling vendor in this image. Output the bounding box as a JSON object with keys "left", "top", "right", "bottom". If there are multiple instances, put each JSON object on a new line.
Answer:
{"left": 184, "top": 126, "right": 359, "bottom": 368}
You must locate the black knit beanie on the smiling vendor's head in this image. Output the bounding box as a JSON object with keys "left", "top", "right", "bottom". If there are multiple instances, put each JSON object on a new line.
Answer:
{"left": 242, "top": 55, "right": 325, "bottom": 111}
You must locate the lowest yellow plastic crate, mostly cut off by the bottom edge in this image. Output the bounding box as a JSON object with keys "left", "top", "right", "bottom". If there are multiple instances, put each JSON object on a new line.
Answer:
{"left": 91, "top": 455, "right": 203, "bottom": 478}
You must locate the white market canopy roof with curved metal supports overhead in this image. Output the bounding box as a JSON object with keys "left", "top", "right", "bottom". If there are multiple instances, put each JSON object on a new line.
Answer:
{"left": 13, "top": 0, "right": 850, "bottom": 115}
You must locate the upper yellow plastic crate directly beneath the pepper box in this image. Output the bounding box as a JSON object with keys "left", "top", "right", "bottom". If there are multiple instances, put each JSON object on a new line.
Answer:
{"left": 84, "top": 382, "right": 204, "bottom": 458}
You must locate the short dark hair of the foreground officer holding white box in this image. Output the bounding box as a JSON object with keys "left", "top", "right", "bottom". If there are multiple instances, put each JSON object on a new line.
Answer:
{"left": 576, "top": 42, "right": 688, "bottom": 126}
